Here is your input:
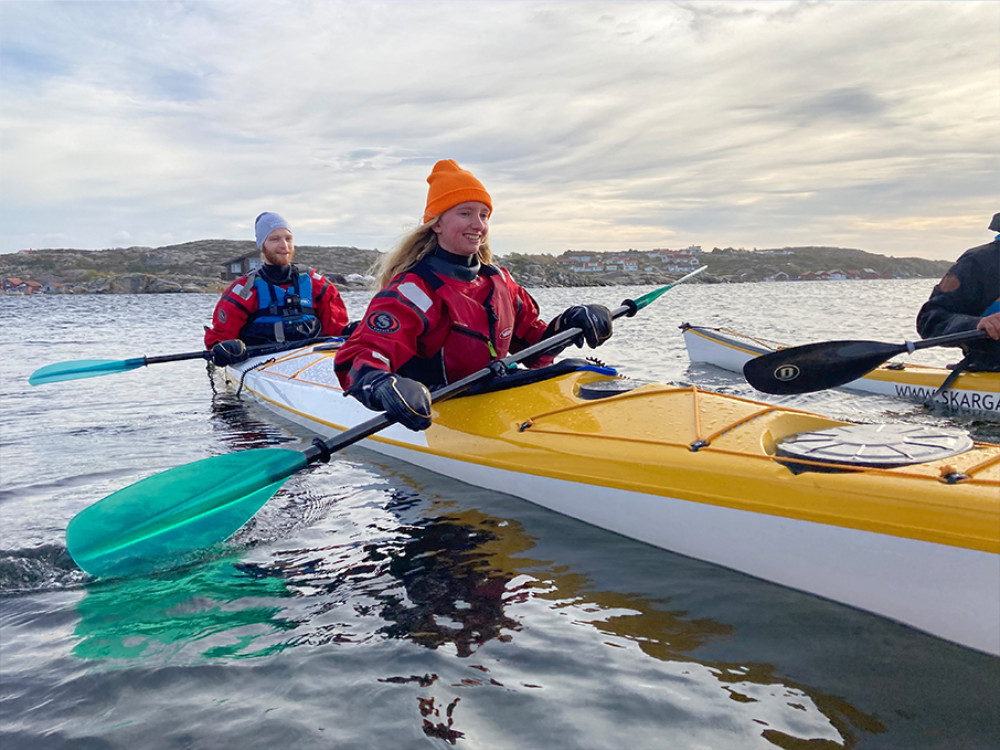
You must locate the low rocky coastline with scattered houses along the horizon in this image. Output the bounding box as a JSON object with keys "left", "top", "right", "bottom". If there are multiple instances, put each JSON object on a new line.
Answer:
{"left": 0, "top": 240, "right": 952, "bottom": 294}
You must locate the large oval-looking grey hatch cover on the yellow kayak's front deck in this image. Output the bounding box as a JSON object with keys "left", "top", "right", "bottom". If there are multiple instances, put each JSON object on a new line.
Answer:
{"left": 778, "top": 424, "right": 972, "bottom": 468}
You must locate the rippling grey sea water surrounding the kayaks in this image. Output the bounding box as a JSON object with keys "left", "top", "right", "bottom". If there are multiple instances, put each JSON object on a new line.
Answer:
{"left": 0, "top": 279, "right": 1000, "bottom": 750}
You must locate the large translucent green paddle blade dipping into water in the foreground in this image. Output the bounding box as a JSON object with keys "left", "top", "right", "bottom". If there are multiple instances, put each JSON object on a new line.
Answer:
{"left": 66, "top": 448, "right": 308, "bottom": 576}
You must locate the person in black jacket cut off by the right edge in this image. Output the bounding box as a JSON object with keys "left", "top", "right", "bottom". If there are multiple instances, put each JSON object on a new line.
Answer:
{"left": 917, "top": 213, "right": 1000, "bottom": 372}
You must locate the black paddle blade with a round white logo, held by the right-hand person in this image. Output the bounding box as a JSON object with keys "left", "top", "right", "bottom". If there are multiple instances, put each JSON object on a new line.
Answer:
{"left": 743, "top": 341, "right": 907, "bottom": 395}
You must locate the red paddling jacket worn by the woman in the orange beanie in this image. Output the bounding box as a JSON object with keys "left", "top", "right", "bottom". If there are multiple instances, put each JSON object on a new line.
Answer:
{"left": 336, "top": 249, "right": 552, "bottom": 391}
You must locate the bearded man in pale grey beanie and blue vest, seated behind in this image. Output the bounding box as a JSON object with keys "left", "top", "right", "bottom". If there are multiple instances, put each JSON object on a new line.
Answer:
{"left": 205, "top": 211, "right": 347, "bottom": 367}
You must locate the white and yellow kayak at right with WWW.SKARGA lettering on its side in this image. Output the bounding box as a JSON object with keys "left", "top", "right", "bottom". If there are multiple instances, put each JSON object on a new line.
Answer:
{"left": 681, "top": 323, "right": 1000, "bottom": 419}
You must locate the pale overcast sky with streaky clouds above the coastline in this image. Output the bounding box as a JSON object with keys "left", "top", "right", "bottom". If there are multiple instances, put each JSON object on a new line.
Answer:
{"left": 0, "top": 0, "right": 1000, "bottom": 259}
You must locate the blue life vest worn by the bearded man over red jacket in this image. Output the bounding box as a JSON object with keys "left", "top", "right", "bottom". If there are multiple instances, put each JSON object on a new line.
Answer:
{"left": 240, "top": 268, "right": 323, "bottom": 345}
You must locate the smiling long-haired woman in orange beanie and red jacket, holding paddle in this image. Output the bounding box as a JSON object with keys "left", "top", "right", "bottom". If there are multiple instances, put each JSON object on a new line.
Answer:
{"left": 336, "top": 159, "right": 611, "bottom": 430}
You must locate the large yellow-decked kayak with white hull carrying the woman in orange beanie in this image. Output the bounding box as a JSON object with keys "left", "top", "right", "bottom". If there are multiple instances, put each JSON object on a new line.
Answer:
{"left": 226, "top": 344, "right": 1000, "bottom": 655}
